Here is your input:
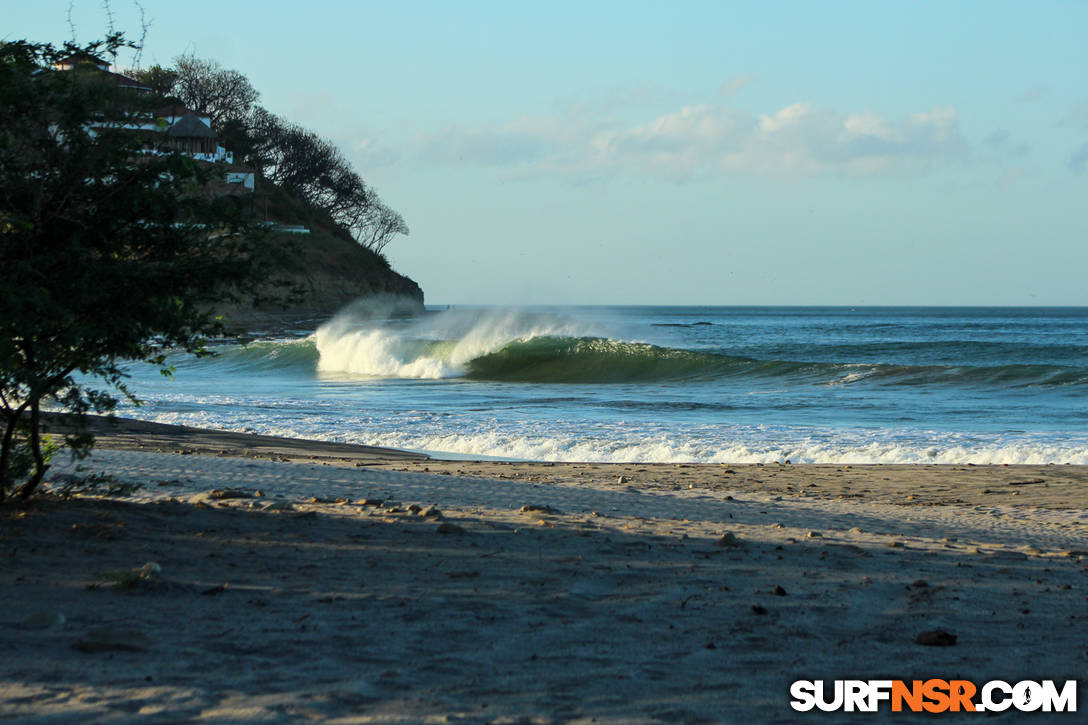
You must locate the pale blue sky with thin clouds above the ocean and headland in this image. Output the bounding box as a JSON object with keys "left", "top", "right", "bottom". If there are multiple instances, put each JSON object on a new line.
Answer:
{"left": 8, "top": 0, "right": 1088, "bottom": 306}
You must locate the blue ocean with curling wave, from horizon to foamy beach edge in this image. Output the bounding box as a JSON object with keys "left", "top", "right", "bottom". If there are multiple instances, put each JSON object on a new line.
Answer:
{"left": 110, "top": 305, "right": 1088, "bottom": 464}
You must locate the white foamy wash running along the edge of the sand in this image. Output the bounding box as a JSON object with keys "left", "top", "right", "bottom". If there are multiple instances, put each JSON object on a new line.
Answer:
{"left": 112, "top": 398, "right": 1088, "bottom": 465}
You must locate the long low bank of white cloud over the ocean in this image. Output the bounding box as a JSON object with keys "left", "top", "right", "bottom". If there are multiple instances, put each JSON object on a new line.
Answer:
{"left": 423, "top": 96, "right": 969, "bottom": 177}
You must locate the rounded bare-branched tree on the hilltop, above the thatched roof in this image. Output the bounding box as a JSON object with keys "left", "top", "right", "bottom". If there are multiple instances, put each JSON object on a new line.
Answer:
{"left": 171, "top": 56, "right": 260, "bottom": 127}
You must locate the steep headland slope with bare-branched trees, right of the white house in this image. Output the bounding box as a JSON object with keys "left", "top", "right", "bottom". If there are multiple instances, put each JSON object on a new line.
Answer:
{"left": 127, "top": 56, "right": 423, "bottom": 327}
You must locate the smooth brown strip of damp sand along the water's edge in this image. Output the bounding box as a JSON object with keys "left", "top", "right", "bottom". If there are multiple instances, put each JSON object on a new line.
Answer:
{"left": 61, "top": 416, "right": 1088, "bottom": 509}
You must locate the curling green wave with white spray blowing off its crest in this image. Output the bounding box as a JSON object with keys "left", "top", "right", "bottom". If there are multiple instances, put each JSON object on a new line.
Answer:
{"left": 187, "top": 310, "right": 1088, "bottom": 389}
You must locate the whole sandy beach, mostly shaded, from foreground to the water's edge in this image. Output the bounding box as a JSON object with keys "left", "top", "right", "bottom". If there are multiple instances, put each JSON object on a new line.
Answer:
{"left": 0, "top": 421, "right": 1088, "bottom": 723}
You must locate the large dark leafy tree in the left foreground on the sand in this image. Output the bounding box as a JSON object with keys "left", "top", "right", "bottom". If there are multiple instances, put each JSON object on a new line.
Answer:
{"left": 0, "top": 36, "right": 280, "bottom": 500}
